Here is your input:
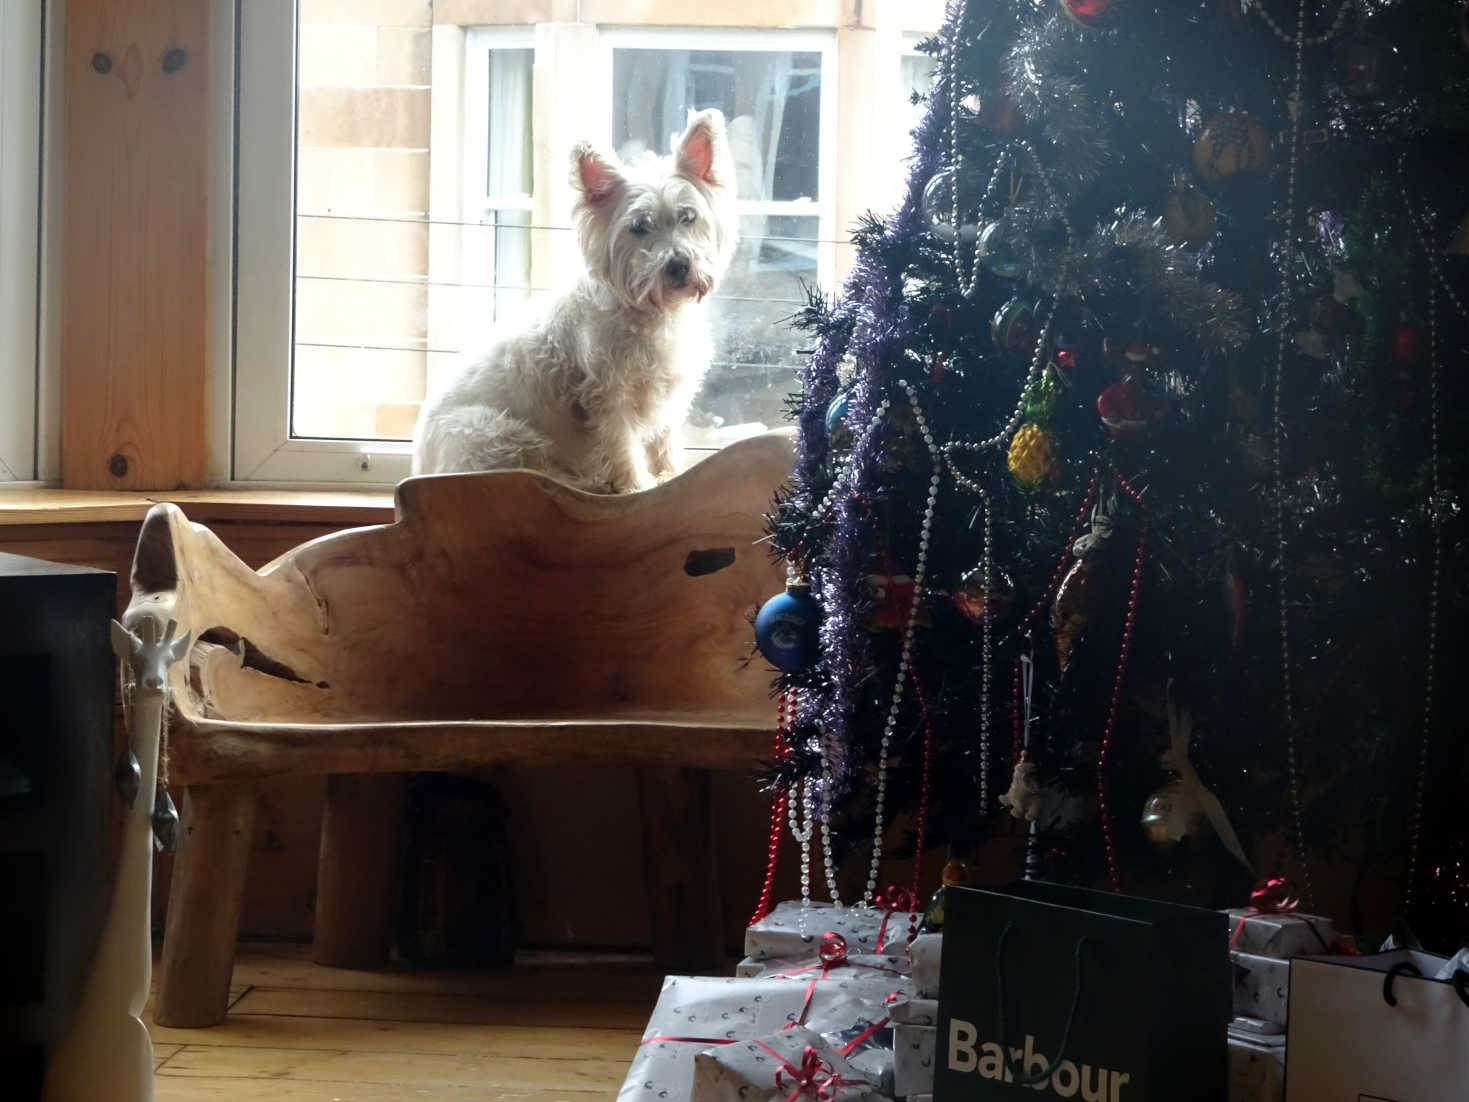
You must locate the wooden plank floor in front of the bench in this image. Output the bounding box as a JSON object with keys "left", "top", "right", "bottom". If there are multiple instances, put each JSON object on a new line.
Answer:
{"left": 147, "top": 946, "right": 663, "bottom": 1102}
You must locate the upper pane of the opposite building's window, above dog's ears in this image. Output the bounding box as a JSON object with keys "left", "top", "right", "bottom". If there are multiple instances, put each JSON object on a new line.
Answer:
{"left": 613, "top": 50, "right": 821, "bottom": 200}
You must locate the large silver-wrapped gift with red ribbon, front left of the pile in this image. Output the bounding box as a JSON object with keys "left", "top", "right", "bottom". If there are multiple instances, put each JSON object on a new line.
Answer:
{"left": 617, "top": 976, "right": 884, "bottom": 1102}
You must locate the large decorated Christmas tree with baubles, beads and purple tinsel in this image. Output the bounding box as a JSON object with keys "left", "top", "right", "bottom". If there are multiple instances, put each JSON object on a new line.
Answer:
{"left": 757, "top": 0, "right": 1469, "bottom": 939}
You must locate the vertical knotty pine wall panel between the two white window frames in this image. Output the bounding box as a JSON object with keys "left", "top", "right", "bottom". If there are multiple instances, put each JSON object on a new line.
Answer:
{"left": 60, "top": 0, "right": 210, "bottom": 489}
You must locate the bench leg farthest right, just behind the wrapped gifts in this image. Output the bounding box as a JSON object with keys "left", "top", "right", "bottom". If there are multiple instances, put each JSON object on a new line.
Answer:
{"left": 638, "top": 766, "right": 724, "bottom": 973}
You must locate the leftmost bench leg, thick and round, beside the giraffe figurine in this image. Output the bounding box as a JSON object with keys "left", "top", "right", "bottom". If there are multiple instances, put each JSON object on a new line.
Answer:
{"left": 153, "top": 785, "right": 257, "bottom": 1029}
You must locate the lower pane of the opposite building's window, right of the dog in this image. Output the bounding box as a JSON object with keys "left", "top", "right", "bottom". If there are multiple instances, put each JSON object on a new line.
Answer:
{"left": 689, "top": 215, "right": 823, "bottom": 445}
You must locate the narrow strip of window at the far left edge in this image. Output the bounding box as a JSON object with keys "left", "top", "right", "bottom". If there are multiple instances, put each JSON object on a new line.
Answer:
{"left": 0, "top": 3, "right": 43, "bottom": 482}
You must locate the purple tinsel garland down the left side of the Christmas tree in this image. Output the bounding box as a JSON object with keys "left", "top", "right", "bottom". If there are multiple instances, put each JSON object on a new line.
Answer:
{"left": 795, "top": 0, "right": 964, "bottom": 804}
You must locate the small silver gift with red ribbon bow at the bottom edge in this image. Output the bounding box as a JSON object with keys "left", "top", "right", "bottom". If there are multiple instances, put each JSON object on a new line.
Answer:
{"left": 689, "top": 1029, "right": 886, "bottom": 1102}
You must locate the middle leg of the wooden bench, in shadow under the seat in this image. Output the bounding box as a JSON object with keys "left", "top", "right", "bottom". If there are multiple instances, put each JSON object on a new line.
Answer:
{"left": 311, "top": 773, "right": 408, "bottom": 968}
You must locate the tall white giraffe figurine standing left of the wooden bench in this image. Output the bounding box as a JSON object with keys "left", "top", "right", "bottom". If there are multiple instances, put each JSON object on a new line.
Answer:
{"left": 41, "top": 620, "right": 190, "bottom": 1102}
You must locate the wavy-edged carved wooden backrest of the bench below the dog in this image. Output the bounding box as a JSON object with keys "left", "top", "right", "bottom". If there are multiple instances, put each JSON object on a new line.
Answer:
{"left": 129, "top": 433, "right": 790, "bottom": 726}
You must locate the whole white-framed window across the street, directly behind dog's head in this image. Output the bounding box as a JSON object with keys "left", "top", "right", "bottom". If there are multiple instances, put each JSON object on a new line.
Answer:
{"left": 604, "top": 31, "right": 836, "bottom": 447}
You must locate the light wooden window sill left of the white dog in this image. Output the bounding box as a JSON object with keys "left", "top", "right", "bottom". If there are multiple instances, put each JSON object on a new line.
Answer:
{"left": 0, "top": 488, "right": 394, "bottom": 526}
